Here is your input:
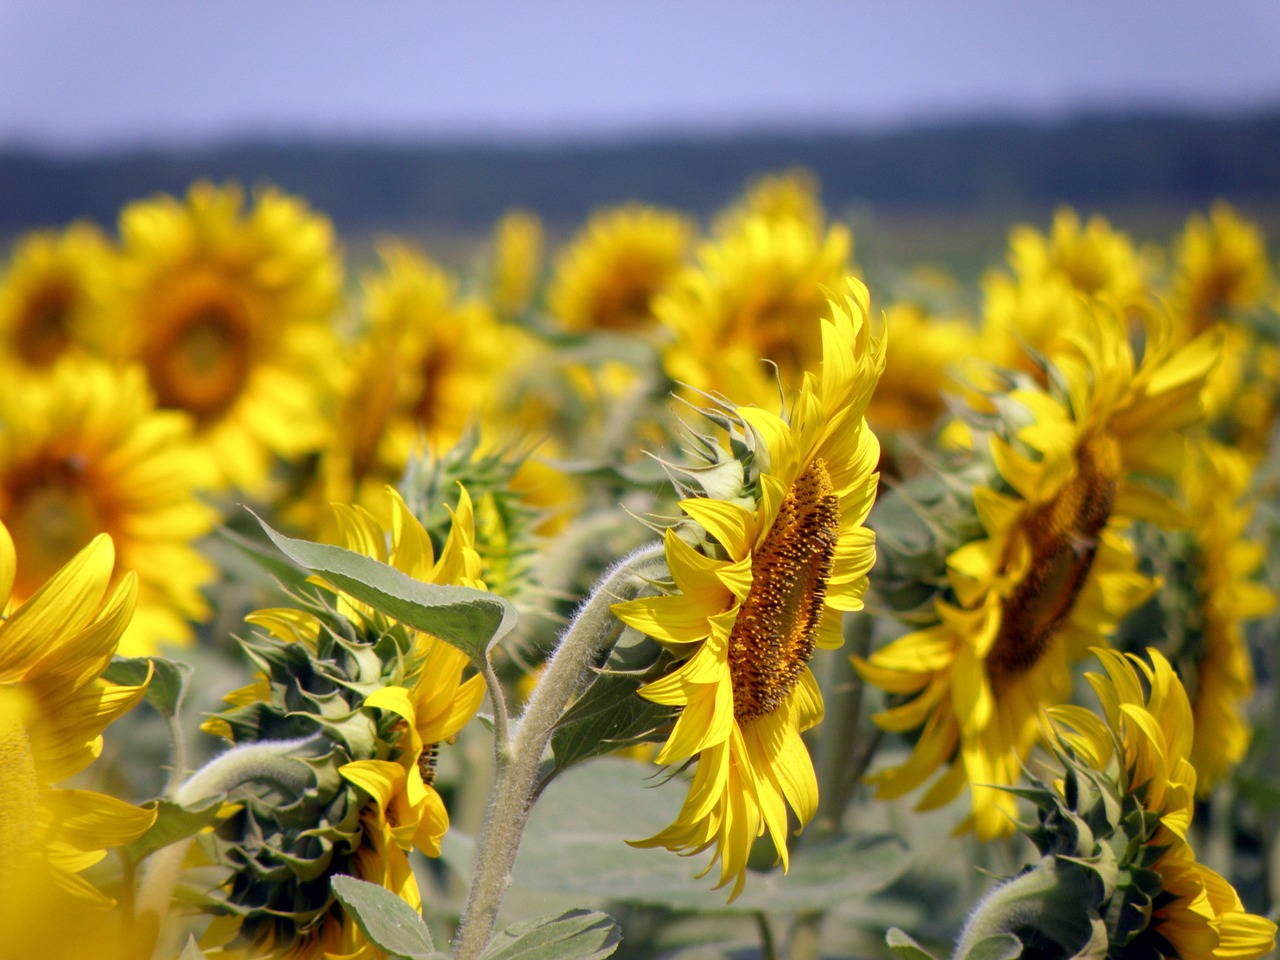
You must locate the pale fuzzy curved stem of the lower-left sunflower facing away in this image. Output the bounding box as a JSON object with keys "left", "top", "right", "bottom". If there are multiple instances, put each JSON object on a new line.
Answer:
{"left": 134, "top": 736, "right": 323, "bottom": 947}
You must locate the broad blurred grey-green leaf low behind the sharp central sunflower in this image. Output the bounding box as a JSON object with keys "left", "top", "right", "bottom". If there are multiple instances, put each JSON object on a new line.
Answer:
{"left": 515, "top": 758, "right": 909, "bottom": 914}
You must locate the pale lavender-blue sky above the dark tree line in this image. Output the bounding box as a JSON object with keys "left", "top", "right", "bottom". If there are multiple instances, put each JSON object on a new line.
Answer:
{"left": 0, "top": 0, "right": 1280, "bottom": 148}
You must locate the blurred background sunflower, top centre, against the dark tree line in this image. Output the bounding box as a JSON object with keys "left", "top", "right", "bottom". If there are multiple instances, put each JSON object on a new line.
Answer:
{"left": 547, "top": 205, "right": 694, "bottom": 333}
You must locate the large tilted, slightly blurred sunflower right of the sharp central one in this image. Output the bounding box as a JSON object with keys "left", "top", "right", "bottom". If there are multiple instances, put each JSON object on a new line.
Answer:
{"left": 856, "top": 303, "right": 1217, "bottom": 838}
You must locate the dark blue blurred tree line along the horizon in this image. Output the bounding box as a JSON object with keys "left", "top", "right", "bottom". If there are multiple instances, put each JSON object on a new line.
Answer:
{"left": 0, "top": 110, "right": 1280, "bottom": 232}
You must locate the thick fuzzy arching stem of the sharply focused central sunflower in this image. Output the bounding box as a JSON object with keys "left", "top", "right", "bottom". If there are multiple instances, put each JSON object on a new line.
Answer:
{"left": 453, "top": 544, "right": 663, "bottom": 960}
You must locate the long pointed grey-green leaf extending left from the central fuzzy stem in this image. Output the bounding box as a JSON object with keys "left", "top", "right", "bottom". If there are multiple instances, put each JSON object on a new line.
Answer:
{"left": 257, "top": 517, "right": 516, "bottom": 664}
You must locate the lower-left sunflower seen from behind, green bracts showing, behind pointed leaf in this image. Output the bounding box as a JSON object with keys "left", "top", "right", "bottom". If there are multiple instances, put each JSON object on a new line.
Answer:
{"left": 204, "top": 490, "right": 484, "bottom": 960}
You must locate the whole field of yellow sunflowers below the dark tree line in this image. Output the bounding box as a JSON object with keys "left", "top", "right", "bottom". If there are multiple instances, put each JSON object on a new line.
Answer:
{"left": 0, "top": 172, "right": 1280, "bottom": 960}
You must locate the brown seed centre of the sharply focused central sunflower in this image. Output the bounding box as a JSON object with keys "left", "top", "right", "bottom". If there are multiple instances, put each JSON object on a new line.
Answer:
{"left": 728, "top": 460, "right": 840, "bottom": 723}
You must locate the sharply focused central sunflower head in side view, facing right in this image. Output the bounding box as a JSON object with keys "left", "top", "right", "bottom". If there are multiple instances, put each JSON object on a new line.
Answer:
{"left": 613, "top": 279, "right": 884, "bottom": 896}
